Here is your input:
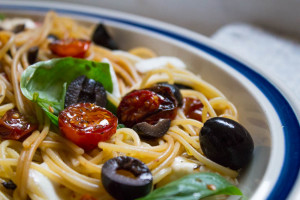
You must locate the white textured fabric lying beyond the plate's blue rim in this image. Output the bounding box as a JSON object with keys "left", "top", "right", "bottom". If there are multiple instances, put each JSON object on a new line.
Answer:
{"left": 212, "top": 24, "right": 300, "bottom": 102}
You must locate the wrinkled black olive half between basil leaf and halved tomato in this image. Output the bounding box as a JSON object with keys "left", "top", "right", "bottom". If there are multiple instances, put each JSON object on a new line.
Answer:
{"left": 65, "top": 76, "right": 107, "bottom": 108}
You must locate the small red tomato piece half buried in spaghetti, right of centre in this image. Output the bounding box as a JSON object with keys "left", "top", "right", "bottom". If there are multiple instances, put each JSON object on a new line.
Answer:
{"left": 182, "top": 97, "right": 203, "bottom": 122}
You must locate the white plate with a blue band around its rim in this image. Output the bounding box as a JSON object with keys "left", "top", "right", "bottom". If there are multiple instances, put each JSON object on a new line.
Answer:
{"left": 0, "top": 1, "right": 300, "bottom": 200}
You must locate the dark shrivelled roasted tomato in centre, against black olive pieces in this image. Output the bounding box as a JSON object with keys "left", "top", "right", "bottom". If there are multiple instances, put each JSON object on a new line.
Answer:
{"left": 117, "top": 88, "right": 177, "bottom": 127}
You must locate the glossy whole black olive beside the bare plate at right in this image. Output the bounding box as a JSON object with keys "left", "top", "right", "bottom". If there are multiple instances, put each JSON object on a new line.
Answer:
{"left": 200, "top": 117, "right": 254, "bottom": 170}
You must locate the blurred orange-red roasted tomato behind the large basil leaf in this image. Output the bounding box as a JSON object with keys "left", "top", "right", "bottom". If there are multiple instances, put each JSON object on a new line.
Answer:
{"left": 49, "top": 38, "right": 91, "bottom": 58}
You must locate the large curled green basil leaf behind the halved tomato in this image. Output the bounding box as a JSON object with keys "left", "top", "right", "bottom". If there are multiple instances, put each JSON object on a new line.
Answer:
{"left": 21, "top": 58, "right": 113, "bottom": 125}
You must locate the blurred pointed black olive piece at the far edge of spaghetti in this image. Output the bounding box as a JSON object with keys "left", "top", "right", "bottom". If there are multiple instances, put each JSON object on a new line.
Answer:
{"left": 92, "top": 24, "right": 118, "bottom": 50}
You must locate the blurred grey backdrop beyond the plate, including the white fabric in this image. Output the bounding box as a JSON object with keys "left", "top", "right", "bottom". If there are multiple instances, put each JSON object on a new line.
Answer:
{"left": 2, "top": 0, "right": 300, "bottom": 102}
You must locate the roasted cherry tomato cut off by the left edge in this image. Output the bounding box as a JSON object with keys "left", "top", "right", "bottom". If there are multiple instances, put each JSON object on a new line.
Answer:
{"left": 0, "top": 109, "right": 37, "bottom": 140}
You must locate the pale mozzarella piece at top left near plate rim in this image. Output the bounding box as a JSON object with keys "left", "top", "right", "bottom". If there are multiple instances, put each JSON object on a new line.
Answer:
{"left": 0, "top": 18, "right": 36, "bottom": 30}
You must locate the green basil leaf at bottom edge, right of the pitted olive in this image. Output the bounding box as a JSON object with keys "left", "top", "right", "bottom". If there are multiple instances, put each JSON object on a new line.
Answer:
{"left": 138, "top": 173, "right": 243, "bottom": 200}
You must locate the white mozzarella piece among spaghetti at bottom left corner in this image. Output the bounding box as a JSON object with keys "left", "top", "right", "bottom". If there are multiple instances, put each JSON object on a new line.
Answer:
{"left": 28, "top": 163, "right": 60, "bottom": 200}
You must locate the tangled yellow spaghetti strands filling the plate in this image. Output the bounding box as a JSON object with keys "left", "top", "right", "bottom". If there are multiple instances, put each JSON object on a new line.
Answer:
{"left": 0, "top": 12, "right": 238, "bottom": 199}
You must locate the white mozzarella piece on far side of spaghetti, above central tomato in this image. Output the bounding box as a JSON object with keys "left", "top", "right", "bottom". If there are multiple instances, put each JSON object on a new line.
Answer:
{"left": 135, "top": 56, "right": 186, "bottom": 73}
